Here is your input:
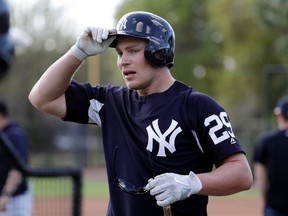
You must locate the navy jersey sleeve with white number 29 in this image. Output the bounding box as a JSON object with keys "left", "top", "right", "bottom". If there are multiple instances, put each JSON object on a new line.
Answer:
{"left": 189, "top": 92, "right": 245, "bottom": 166}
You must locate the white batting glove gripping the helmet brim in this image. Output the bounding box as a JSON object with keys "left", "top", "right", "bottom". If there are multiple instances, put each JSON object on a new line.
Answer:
{"left": 71, "top": 27, "right": 116, "bottom": 61}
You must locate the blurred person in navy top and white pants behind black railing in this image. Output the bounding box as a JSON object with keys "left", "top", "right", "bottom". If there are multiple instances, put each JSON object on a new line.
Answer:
{"left": 0, "top": 101, "right": 32, "bottom": 216}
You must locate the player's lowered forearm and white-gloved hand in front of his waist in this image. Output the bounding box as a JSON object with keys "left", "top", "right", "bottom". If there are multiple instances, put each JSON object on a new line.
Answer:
{"left": 146, "top": 153, "right": 252, "bottom": 207}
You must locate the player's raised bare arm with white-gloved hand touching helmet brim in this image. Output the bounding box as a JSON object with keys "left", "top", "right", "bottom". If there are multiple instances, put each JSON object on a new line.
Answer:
{"left": 29, "top": 27, "right": 115, "bottom": 118}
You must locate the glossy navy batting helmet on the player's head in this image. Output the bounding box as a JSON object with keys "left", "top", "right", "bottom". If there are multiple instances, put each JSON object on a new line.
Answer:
{"left": 110, "top": 11, "right": 175, "bottom": 68}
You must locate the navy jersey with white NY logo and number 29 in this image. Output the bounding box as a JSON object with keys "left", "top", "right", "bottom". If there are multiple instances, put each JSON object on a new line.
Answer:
{"left": 64, "top": 81, "right": 243, "bottom": 216}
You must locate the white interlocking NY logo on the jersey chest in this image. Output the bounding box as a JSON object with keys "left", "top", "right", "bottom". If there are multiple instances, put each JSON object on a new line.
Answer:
{"left": 146, "top": 119, "right": 182, "bottom": 157}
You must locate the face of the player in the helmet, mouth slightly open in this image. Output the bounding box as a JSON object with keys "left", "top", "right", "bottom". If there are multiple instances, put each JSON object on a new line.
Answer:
{"left": 116, "top": 36, "right": 159, "bottom": 94}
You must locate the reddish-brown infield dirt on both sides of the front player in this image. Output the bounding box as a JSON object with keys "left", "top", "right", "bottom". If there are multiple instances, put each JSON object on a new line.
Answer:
{"left": 82, "top": 170, "right": 261, "bottom": 216}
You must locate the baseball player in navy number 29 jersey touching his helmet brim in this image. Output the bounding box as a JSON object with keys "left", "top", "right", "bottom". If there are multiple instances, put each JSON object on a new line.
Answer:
{"left": 29, "top": 11, "right": 252, "bottom": 216}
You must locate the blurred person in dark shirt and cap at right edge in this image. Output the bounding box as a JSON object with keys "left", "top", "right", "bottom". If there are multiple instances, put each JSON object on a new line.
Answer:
{"left": 254, "top": 96, "right": 288, "bottom": 216}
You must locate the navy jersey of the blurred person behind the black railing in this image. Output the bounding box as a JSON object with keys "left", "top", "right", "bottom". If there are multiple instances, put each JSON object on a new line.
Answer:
{"left": 0, "top": 122, "right": 28, "bottom": 196}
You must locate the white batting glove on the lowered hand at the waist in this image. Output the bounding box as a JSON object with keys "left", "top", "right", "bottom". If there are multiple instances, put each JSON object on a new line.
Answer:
{"left": 146, "top": 171, "right": 202, "bottom": 207}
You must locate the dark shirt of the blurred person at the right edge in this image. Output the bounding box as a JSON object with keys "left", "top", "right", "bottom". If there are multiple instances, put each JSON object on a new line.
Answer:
{"left": 253, "top": 130, "right": 288, "bottom": 215}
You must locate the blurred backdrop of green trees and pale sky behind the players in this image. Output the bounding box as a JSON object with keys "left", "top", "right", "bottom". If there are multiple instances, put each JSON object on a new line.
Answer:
{"left": 0, "top": 0, "right": 288, "bottom": 168}
